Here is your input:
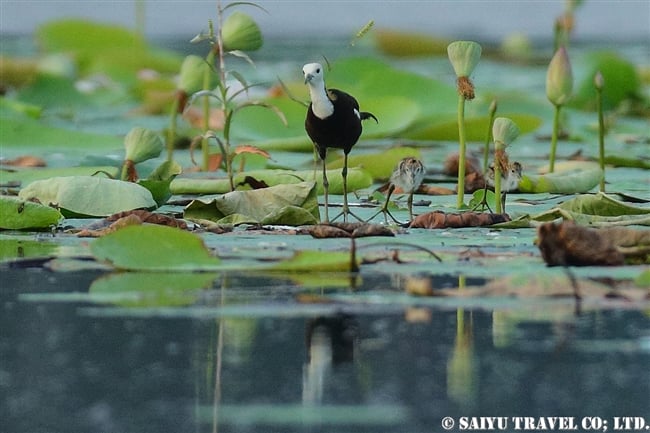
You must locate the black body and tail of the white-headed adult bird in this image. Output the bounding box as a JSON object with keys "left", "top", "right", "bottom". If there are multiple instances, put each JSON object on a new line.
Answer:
{"left": 305, "top": 89, "right": 377, "bottom": 160}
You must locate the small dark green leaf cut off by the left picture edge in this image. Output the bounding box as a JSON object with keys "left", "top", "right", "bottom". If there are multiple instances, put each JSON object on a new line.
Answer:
{"left": 0, "top": 195, "right": 62, "bottom": 230}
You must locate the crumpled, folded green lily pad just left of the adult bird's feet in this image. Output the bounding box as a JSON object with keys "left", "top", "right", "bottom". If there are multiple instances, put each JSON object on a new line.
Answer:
{"left": 184, "top": 182, "right": 320, "bottom": 225}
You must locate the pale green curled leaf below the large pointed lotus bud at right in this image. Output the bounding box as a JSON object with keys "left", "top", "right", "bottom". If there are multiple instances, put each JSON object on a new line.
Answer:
{"left": 519, "top": 161, "right": 603, "bottom": 194}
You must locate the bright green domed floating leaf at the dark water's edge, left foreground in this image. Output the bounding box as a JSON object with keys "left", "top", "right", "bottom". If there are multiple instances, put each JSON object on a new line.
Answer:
{"left": 90, "top": 224, "right": 219, "bottom": 272}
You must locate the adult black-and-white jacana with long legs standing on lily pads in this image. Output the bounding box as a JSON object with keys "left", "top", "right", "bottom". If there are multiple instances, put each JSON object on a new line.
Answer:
{"left": 302, "top": 63, "right": 377, "bottom": 223}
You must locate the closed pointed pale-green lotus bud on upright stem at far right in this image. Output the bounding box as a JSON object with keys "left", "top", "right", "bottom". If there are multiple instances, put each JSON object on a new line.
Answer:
{"left": 546, "top": 47, "right": 573, "bottom": 173}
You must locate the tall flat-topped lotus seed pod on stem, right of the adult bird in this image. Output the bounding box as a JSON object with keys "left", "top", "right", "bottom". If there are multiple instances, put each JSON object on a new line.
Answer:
{"left": 447, "top": 41, "right": 481, "bottom": 208}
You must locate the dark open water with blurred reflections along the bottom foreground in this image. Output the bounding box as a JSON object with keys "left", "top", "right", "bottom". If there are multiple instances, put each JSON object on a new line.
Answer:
{"left": 0, "top": 268, "right": 650, "bottom": 433}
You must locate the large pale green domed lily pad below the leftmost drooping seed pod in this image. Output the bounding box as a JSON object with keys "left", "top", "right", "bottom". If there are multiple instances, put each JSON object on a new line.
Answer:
{"left": 19, "top": 176, "right": 156, "bottom": 217}
